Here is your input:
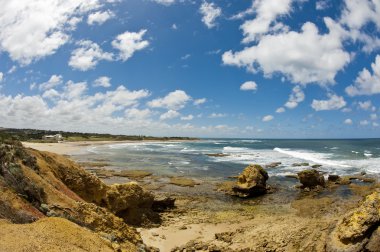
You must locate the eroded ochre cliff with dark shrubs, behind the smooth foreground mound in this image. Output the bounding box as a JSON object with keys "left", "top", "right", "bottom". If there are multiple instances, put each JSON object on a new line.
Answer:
{"left": 0, "top": 142, "right": 158, "bottom": 251}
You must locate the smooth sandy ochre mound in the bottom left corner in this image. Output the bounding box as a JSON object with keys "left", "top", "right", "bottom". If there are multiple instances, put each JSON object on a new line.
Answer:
{"left": 0, "top": 218, "right": 117, "bottom": 252}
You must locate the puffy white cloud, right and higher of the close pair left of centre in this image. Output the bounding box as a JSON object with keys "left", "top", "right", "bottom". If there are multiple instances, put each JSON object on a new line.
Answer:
{"left": 112, "top": 30, "right": 149, "bottom": 61}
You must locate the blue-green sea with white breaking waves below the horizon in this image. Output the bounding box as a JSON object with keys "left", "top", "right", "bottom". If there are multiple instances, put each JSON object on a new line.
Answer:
{"left": 81, "top": 139, "right": 380, "bottom": 179}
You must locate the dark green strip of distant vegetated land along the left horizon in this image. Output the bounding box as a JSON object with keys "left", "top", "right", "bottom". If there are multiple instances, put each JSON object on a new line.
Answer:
{"left": 0, "top": 128, "right": 200, "bottom": 142}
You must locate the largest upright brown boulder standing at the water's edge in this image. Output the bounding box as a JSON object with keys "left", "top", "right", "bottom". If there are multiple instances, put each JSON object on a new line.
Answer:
{"left": 232, "top": 165, "right": 269, "bottom": 198}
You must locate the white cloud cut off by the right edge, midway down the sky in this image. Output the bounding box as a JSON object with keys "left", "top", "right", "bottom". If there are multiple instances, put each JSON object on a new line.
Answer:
{"left": 346, "top": 55, "right": 380, "bottom": 96}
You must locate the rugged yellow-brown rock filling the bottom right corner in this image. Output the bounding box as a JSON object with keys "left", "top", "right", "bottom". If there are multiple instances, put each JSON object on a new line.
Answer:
{"left": 326, "top": 191, "right": 380, "bottom": 252}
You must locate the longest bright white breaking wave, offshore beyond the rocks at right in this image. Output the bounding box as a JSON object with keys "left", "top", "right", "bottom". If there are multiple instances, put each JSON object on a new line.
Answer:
{"left": 273, "top": 148, "right": 351, "bottom": 168}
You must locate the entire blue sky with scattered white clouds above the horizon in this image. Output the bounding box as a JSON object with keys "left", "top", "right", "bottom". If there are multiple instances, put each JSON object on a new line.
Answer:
{"left": 0, "top": 0, "right": 380, "bottom": 138}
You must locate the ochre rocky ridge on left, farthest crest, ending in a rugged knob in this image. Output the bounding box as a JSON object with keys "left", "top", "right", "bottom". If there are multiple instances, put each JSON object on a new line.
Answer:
{"left": 30, "top": 150, "right": 159, "bottom": 225}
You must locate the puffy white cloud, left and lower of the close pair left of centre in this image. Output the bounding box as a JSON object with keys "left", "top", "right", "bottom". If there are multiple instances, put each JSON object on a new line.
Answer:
{"left": 69, "top": 40, "right": 113, "bottom": 71}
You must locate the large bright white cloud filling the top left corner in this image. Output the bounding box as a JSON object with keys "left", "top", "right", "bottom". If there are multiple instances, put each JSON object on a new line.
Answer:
{"left": 0, "top": 0, "right": 100, "bottom": 65}
